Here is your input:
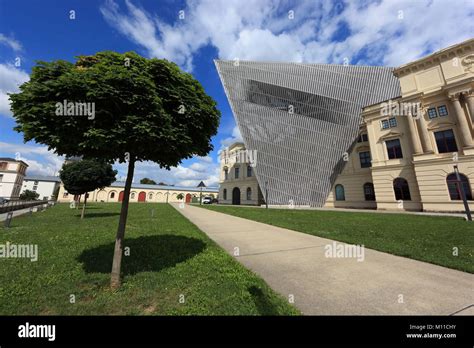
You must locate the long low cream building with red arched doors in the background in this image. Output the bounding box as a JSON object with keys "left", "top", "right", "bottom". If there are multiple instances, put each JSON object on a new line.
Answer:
{"left": 58, "top": 181, "right": 219, "bottom": 203}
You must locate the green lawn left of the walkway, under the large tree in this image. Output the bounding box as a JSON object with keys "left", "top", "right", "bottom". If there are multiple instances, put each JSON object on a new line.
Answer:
{"left": 0, "top": 203, "right": 299, "bottom": 315}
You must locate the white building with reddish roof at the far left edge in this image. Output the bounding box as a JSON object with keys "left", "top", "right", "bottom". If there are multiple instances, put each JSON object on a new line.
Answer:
{"left": 0, "top": 157, "right": 28, "bottom": 200}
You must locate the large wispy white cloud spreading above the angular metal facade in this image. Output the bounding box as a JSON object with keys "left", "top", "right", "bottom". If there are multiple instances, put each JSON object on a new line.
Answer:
{"left": 101, "top": 0, "right": 474, "bottom": 70}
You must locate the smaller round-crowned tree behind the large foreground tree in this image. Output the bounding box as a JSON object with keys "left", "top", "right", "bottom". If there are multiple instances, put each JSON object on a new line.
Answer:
{"left": 59, "top": 159, "right": 117, "bottom": 219}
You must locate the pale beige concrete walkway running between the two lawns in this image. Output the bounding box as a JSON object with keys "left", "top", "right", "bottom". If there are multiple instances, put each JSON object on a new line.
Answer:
{"left": 173, "top": 204, "right": 474, "bottom": 315}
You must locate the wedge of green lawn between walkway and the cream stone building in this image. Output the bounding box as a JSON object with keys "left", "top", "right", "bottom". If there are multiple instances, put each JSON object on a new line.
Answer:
{"left": 199, "top": 205, "right": 474, "bottom": 273}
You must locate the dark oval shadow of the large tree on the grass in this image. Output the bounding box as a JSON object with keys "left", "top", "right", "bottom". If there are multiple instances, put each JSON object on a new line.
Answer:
{"left": 77, "top": 234, "right": 206, "bottom": 275}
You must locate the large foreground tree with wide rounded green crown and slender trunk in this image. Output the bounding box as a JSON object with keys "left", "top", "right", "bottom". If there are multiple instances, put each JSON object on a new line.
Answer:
{"left": 10, "top": 51, "right": 220, "bottom": 288}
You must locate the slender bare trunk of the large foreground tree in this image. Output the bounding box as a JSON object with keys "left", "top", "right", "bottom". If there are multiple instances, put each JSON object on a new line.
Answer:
{"left": 110, "top": 155, "right": 135, "bottom": 289}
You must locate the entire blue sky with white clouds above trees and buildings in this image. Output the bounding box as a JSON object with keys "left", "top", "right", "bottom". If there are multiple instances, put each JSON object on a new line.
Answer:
{"left": 0, "top": 0, "right": 474, "bottom": 186}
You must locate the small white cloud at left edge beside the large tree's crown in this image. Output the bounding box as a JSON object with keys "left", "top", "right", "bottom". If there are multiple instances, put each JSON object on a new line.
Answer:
{"left": 0, "top": 63, "right": 30, "bottom": 116}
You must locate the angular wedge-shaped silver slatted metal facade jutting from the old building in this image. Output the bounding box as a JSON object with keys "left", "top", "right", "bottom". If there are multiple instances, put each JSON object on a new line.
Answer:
{"left": 215, "top": 60, "right": 400, "bottom": 207}
